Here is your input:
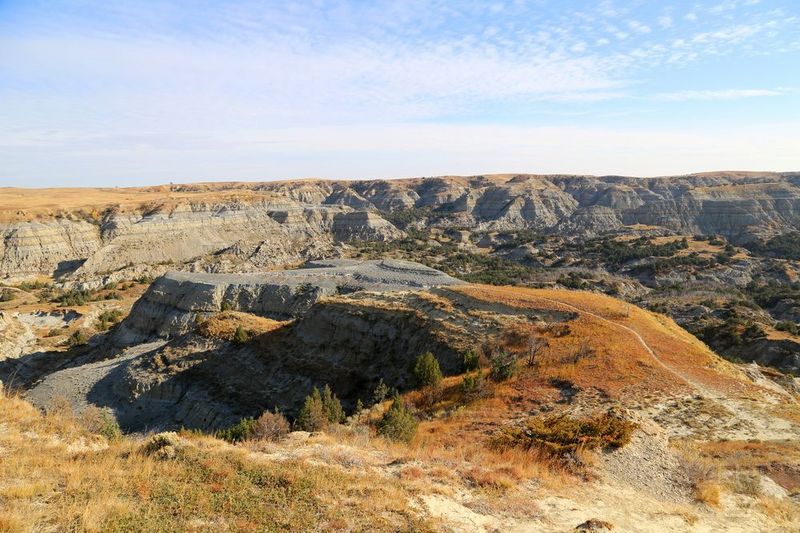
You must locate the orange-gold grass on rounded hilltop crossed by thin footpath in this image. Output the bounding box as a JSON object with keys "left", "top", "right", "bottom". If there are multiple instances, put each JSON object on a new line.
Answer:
{"left": 454, "top": 285, "right": 761, "bottom": 396}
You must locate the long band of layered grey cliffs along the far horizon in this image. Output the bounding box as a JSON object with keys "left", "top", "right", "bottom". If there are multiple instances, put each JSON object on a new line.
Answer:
{"left": 0, "top": 173, "right": 800, "bottom": 280}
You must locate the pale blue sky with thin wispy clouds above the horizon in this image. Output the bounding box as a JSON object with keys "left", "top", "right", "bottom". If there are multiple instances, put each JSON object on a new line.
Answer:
{"left": 0, "top": 0, "right": 800, "bottom": 187}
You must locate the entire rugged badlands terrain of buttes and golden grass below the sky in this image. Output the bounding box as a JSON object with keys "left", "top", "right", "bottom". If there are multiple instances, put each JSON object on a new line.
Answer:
{"left": 0, "top": 172, "right": 800, "bottom": 531}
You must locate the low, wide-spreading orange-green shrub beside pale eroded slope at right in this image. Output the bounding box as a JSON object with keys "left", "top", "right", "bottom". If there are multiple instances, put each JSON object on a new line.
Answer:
{"left": 493, "top": 413, "right": 636, "bottom": 455}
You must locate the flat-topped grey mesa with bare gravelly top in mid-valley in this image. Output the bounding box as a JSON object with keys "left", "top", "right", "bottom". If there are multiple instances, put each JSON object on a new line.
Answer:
{"left": 114, "top": 259, "right": 463, "bottom": 344}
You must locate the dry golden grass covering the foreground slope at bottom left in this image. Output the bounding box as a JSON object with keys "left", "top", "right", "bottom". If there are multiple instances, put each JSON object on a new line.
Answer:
{"left": 0, "top": 388, "right": 429, "bottom": 531}
